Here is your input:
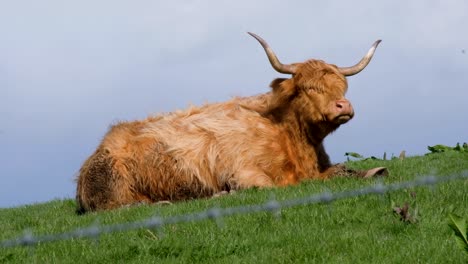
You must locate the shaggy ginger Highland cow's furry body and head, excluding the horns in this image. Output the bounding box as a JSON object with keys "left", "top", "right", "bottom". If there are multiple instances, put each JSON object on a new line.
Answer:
{"left": 76, "top": 37, "right": 378, "bottom": 212}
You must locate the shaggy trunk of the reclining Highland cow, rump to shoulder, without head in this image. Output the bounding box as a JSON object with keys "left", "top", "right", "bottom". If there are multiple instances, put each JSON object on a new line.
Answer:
{"left": 77, "top": 98, "right": 287, "bottom": 211}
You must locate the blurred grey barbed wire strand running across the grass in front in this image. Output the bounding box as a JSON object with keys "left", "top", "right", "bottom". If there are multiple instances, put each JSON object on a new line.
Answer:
{"left": 0, "top": 171, "right": 468, "bottom": 248}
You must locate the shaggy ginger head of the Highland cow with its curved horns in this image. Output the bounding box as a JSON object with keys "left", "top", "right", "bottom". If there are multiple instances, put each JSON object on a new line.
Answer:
{"left": 249, "top": 32, "right": 380, "bottom": 140}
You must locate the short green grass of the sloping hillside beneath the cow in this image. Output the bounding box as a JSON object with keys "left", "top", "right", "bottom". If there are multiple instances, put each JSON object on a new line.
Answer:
{"left": 0, "top": 152, "right": 468, "bottom": 263}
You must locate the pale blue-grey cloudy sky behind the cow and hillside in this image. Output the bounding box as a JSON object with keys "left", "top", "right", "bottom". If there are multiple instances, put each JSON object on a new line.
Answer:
{"left": 0, "top": 0, "right": 468, "bottom": 207}
